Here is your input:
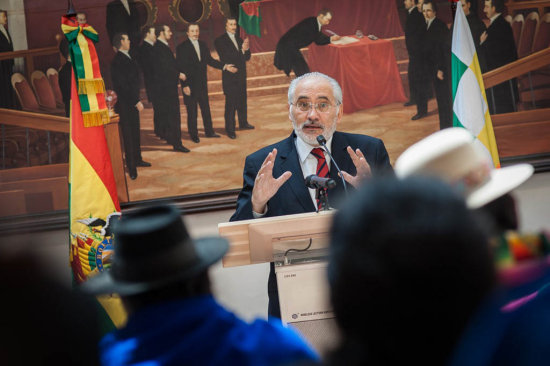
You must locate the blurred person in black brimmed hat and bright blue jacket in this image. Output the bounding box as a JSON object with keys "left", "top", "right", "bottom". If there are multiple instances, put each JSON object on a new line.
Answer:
{"left": 83, "top": 205, "right": 317, "bottom": 365}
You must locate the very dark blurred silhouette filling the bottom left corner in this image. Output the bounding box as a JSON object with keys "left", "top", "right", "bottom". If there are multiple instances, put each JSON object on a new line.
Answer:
{"left": 0, "top": 252, "right": 100, "bottom": 366}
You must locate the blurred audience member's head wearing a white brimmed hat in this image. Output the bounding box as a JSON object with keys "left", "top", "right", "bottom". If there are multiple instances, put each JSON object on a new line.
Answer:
{"left": 395, "top": 127, "right": 533, "bottom": 234}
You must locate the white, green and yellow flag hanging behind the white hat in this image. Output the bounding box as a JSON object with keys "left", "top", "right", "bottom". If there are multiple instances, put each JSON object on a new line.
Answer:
{"left": 451, "top": 2, "right": 500, "bottom": 168}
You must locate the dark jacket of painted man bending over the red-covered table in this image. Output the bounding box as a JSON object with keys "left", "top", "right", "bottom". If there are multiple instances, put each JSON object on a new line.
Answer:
{"left": 274, "top": 17, "right": 330, "bottom": 74}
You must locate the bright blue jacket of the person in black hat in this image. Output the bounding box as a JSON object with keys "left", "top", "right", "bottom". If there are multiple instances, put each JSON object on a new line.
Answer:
{"left": 100, "top": 296, "right": 318, "bottom": 365}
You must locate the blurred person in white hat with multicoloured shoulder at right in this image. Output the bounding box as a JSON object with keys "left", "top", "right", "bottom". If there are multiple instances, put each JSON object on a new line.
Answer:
{"left": 395, "top": 128, "right": 550, "bottom": 366}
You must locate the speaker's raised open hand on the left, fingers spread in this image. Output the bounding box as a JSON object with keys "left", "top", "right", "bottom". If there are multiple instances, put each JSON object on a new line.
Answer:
{"left": 251, "top": 149, "right": 292, "bottom": 213}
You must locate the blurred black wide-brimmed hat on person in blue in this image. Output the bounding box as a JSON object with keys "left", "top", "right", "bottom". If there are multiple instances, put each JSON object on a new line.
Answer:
{"left": 81, "top": 205, "right": 229, "bottom": 296}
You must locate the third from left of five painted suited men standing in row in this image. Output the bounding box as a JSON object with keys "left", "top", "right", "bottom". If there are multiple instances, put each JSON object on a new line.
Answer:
{"left": 153, "top": 24, "right": 189, "bottom": 152}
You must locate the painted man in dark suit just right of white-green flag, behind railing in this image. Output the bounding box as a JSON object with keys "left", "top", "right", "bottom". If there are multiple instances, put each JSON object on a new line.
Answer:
{"left": 481, "top": 0, "right": 518, "bottom": 114}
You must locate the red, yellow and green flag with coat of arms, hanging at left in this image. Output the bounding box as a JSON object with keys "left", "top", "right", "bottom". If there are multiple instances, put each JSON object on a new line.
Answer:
{"left": 62, "top": 17, "right": 126, "bottom": 332}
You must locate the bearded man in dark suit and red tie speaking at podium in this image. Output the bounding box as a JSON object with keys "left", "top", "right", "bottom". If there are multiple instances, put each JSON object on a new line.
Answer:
{"left": 230, "top": 72, "right": 393, "bottom": 317}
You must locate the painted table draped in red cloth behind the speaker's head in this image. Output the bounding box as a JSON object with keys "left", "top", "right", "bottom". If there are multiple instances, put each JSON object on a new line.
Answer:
{"left": 308, "top": 37, "right": 406, "bottom": 113}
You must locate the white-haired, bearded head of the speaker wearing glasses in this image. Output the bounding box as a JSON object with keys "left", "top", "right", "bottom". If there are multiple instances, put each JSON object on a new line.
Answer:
{"left": 288, "top": 72, "right": 344, "bottom": 146}
